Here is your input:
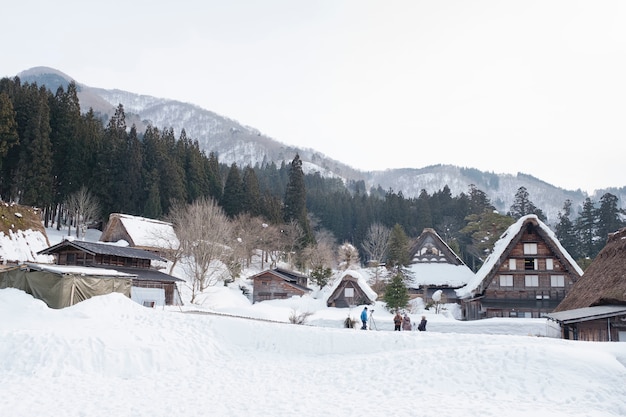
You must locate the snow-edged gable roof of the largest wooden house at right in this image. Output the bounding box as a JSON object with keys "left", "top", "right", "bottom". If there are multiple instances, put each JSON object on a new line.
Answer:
{"left": 456, "top": 214, "right": 583, "bottom": 298}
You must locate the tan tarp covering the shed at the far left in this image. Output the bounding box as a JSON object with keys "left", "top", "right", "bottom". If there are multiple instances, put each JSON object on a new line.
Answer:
{"left": 0, "top": 267, "right": 132, "bottom": 308}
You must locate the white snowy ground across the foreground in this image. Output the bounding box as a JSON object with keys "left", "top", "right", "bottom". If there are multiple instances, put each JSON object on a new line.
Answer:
{"left": 0, "top": 226, "right": 626, "bottom": 417}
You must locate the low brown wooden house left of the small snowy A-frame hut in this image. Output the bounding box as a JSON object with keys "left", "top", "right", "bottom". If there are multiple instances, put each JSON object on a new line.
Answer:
{"left": 251, "top": 268, "right": 311, "bottom": 303}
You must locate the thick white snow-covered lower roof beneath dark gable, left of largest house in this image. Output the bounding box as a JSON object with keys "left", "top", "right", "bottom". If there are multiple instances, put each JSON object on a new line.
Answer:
{"left": 407, "top": 262, "right": 474, "bottom": 288}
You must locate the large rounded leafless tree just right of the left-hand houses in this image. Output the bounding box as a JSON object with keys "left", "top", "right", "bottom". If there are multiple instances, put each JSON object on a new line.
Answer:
{"left": 172, "top": 198, "right": 233, "bottom": 303}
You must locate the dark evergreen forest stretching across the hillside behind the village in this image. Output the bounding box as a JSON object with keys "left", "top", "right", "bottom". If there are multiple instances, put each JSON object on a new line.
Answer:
{"left": 0, "top": 77, "right": 625, "bottom": 270}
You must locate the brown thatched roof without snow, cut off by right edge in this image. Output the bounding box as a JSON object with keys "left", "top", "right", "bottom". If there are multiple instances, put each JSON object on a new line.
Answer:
{"left": 554, "top": 228, "right": 626, "bottom": 312}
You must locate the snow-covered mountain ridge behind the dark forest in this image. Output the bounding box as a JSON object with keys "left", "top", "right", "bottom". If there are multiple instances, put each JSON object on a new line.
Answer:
{"left": 18, "top": 67, "right": 626, "bottom": 224}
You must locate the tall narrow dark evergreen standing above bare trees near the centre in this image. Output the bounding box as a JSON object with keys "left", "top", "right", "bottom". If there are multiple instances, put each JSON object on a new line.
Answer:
{"left": 283, "top": 154, "right": 315, "bottom": 248}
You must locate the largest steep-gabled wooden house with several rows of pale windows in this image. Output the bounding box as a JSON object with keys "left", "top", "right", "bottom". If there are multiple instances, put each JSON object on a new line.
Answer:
{"left": 456, "top": 214, "right": 583, "bottom": 320}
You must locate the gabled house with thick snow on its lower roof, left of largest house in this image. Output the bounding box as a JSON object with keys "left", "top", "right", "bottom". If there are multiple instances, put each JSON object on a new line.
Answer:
{"left": 407, "top": 228, "right": 474, "bottom": 302}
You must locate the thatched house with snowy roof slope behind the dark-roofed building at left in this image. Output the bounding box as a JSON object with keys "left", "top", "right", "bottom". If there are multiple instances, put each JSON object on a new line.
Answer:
{"left": 100, "top": 213, "right": 178, "bottom": 256}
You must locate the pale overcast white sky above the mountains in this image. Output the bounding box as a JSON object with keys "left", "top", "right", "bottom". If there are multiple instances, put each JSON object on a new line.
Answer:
{"left": 0, "top": 0, "right": 626, "bottom": 191}
